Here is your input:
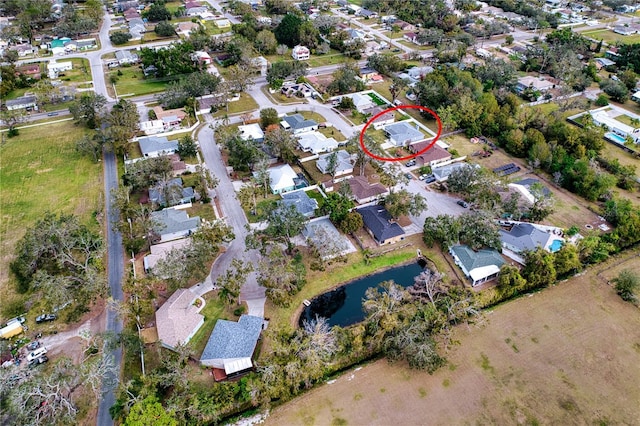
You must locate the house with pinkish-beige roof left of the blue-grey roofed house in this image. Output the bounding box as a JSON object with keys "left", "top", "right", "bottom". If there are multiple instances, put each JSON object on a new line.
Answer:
{"left": 156, "top": 288, "right": 205, "bottom": 351}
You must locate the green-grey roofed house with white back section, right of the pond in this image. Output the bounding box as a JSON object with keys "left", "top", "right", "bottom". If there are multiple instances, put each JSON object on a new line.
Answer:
{"left": 449, "top": 245, "right": 505, "bottom": 287}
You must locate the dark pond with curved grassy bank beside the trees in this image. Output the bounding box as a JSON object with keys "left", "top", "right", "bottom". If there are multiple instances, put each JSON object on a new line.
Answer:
{"left": 298, "top": 263, "right": 423, "bottom": 327}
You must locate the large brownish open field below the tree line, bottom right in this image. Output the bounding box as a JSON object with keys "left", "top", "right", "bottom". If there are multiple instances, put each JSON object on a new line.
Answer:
{"left": 265, "top": 251, "right": 640, "bottom": 425}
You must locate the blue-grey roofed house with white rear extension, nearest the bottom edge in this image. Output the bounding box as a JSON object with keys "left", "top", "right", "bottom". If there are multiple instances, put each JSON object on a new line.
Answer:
{"left": 200, "top": 315, "right": 263, "bottom": 379}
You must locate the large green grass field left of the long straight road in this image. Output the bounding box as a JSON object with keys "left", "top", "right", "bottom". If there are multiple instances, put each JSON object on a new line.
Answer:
{"left": 0, "top": 121, "right": 103, "bottom": 295}
